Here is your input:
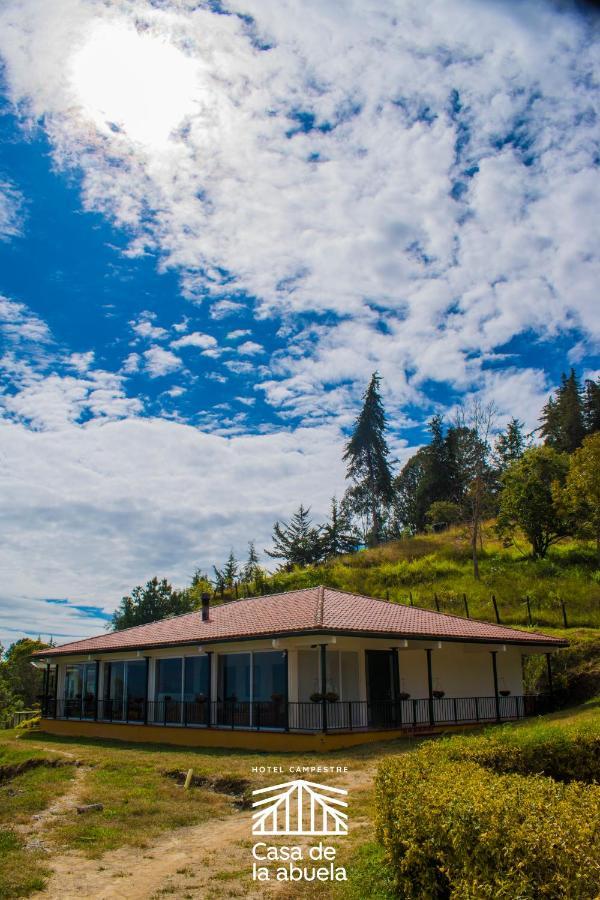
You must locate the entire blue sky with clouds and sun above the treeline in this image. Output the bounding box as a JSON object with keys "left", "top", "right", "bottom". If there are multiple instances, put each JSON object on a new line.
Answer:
{"left": 0, "top": 0, "right": 600, "bottom": 646}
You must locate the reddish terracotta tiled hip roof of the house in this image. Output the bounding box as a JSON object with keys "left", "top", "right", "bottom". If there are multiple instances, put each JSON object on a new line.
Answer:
{"left": 37, "top": 587, "right": 567, "bottom": 656}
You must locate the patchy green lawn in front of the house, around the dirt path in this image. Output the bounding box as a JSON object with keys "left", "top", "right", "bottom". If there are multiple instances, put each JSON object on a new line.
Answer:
{"left": 0, "top": 701, "right": 600, "bottom": 900}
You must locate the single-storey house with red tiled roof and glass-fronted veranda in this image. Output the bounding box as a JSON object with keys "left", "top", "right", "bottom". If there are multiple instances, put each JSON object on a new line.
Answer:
{"left": 36, "top": 587, "right": 567, "bottom": 750}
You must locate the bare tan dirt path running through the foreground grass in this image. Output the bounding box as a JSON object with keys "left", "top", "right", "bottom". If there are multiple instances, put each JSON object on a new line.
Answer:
{"left": 35, "top": 766, "right": 374, "bottom": 900}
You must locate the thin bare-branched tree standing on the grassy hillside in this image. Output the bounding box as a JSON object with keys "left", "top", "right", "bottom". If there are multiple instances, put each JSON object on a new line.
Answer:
{"left": 454, "top": 398, "right": 497, "bottom": 581}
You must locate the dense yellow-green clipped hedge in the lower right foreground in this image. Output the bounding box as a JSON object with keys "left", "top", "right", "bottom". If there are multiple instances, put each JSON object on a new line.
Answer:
{"left": 376, "top": 752, "right": 600, "bottom": 900}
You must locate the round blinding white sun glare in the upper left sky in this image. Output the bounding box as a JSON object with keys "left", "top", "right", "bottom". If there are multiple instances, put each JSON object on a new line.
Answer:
{"left": 70, "top": 22, "right": 197, "bottom": 149}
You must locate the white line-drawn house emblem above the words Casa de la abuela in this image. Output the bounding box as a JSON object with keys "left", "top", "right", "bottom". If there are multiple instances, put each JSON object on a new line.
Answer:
{"left": 252, "top": 779, "right": 348, "bottom": 835}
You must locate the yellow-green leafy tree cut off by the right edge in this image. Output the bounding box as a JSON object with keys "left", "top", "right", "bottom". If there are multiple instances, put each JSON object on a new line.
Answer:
{"left": 553, "top": 432, "right": 600, "bottom": 565}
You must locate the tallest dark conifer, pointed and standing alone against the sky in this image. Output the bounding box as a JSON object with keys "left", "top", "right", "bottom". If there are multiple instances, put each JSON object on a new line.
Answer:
{"left": 343, "top": 372, "right": 394, "bottom": 544}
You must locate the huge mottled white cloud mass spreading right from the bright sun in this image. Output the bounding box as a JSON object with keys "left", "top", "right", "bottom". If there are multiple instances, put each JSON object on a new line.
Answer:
{"left": 0, "top": 0, "right": 600, "bottom": 412}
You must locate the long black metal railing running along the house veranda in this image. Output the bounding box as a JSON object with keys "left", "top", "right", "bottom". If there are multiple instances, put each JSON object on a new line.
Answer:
{"left": 42, "top": 694, "right": 552, "bottom": 732}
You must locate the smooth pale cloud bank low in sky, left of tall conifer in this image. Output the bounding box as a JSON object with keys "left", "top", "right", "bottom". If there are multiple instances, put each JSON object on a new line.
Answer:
{"left": 0, "top": 418, "right": 343, "bottom": 640}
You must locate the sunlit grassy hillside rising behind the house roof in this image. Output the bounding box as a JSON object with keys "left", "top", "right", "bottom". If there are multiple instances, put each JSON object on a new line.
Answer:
{"left": 258, "top": 522, "right": 600, "bottom": 628}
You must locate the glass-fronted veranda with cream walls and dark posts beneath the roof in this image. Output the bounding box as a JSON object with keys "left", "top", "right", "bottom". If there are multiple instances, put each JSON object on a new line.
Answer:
{"left": 36, "top": 634, "right": 552, "bottom": 745}
